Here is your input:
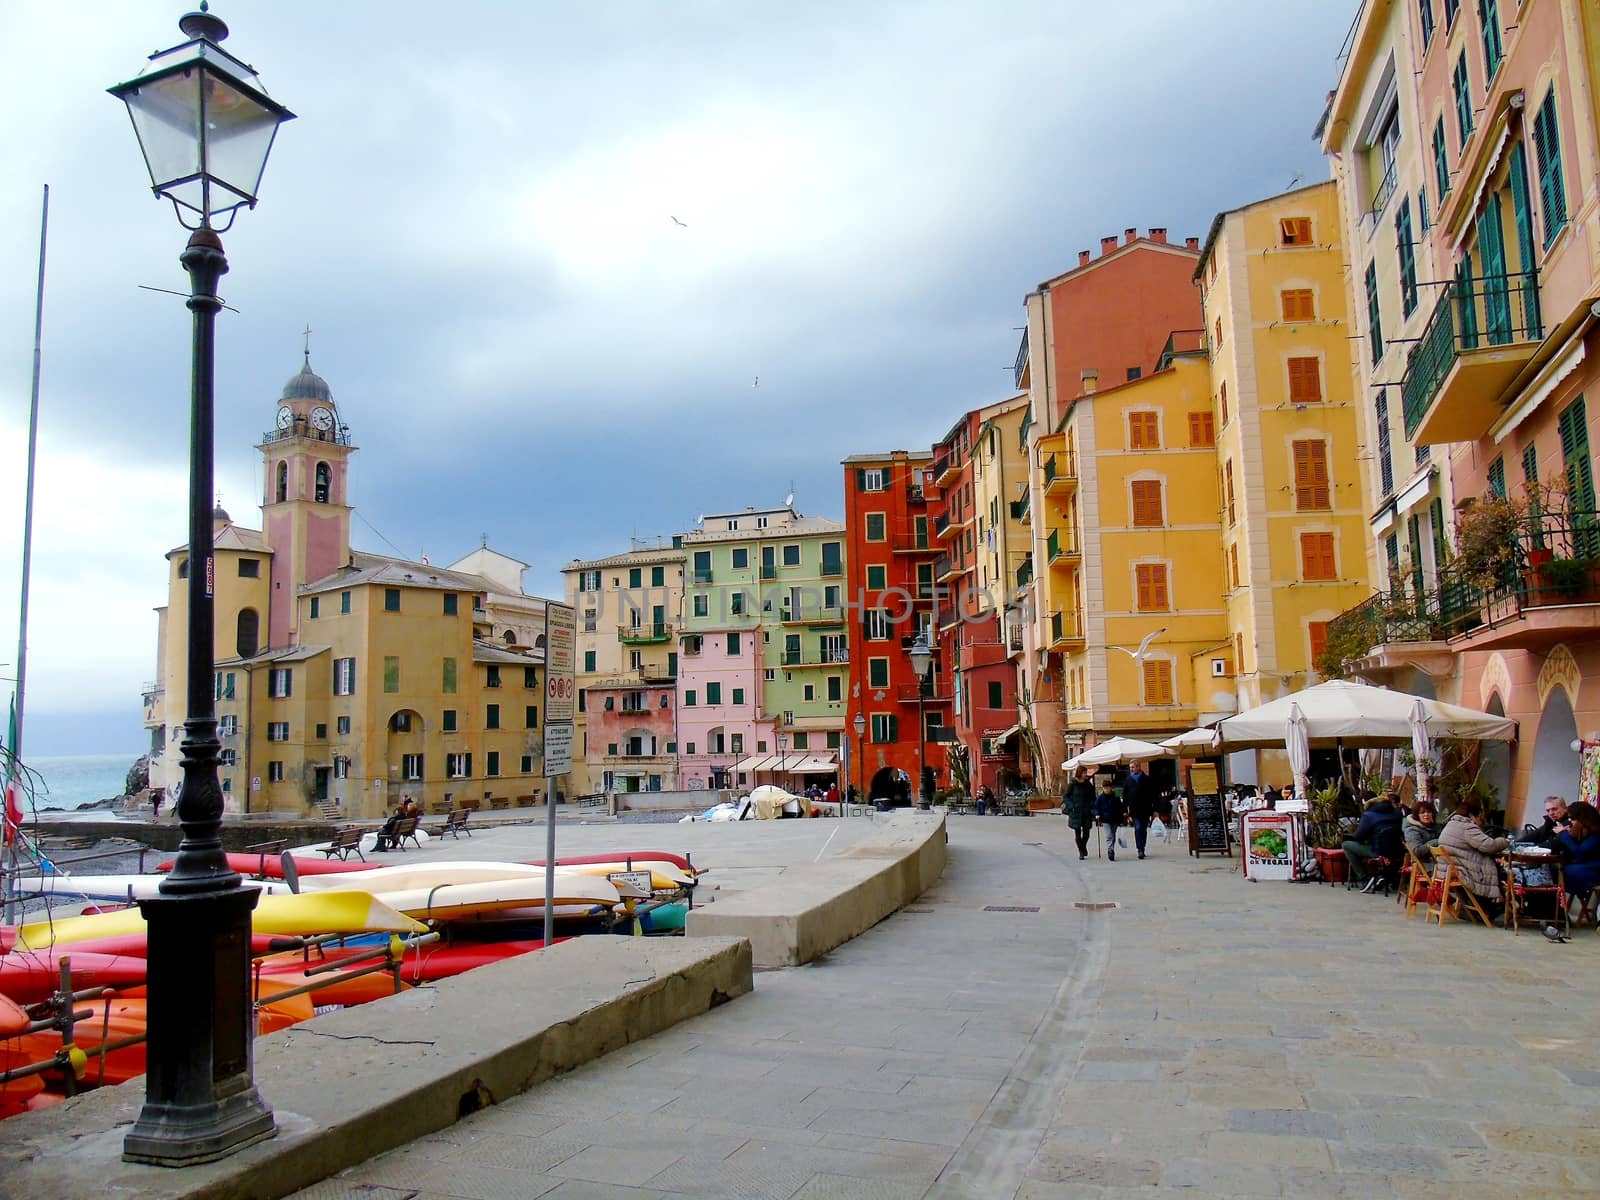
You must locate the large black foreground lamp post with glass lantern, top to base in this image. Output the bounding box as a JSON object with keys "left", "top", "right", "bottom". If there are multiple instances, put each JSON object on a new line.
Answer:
{"left": 110, "top": 3, "right": 294, "bottom": 1166}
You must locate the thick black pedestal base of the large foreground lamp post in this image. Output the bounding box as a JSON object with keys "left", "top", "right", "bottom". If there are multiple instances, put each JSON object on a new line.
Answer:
{"left": 122, "top": 886, "right": 277, "bottom": 1166}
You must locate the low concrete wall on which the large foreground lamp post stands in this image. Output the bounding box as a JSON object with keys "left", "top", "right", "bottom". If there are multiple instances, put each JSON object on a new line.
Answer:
{"left": 0, "top": 938, "right": 750, "bottom": 1200}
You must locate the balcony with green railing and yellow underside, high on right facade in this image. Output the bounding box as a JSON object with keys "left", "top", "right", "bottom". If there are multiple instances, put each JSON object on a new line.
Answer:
{"left": 1400, "top": 270, "right": 1544, "bottom": 445}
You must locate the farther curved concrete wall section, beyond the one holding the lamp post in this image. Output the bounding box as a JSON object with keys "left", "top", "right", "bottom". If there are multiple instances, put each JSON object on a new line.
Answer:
{"left": 685, "top": 813, "right": 947, "bottom": 966}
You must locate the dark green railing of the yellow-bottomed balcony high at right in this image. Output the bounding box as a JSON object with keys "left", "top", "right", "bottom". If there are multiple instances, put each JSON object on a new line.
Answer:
{"left": 1400, "top": 270, "right": 1544, "bottom": 440}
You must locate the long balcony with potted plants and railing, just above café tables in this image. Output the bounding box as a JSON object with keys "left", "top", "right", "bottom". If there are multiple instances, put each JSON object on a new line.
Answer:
{"left": 1328, "top": 512, "right": 1600, "bottom": 675}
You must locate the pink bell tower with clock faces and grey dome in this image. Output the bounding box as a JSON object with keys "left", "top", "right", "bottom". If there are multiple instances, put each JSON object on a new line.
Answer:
{"left": 256, "top": 346, "right": 355, "bottom": 646}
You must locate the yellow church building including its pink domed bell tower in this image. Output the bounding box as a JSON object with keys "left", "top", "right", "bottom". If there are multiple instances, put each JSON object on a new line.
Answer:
{"left": 146, "top": 357, "right": 546, "bottom": 816}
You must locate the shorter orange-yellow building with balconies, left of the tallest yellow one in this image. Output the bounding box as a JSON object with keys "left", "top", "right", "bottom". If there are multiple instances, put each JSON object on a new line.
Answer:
{"left": 1035, "top": 350, "right": 1229, "bottom": 742}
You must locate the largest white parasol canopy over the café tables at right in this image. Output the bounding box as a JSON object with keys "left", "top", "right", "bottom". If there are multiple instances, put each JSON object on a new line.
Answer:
{"left": 1216, "top": 680, "right": 1517, "bottom": 750}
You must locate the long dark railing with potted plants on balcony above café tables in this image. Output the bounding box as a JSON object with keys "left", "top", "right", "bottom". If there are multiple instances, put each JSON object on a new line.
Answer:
{"left": 1328, "top": 512, "right": 1600, "bottom": 659}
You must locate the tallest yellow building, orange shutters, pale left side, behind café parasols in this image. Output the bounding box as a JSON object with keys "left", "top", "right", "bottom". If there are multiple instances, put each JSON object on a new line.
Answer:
{"left": 1195, "top": 182, "right": 1371, "bottom": 782}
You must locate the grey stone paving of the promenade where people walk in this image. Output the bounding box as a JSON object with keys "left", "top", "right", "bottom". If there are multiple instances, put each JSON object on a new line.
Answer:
{"left": 299, "top": 814, "right": 1600, "bottom": 1200}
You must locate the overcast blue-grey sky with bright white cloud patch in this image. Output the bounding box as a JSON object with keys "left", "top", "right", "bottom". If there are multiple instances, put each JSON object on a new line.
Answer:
{"left": 0, "top": 0, "right": 1357, "bottom": 752}
